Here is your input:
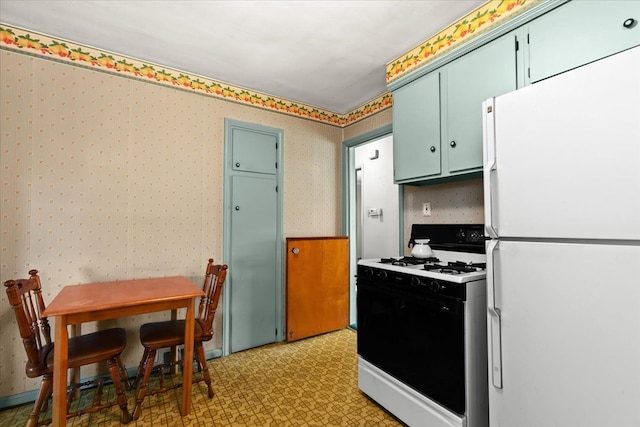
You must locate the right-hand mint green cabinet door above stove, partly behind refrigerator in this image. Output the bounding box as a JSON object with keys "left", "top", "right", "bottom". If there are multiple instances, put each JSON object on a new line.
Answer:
{"left": 442, "top": 33, "right": 517, "bottom": 174}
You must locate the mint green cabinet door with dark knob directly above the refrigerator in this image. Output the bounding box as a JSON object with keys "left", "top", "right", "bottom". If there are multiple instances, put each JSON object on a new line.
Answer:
{"left": 529, "top": 0, "right": 640, "bottom": 83}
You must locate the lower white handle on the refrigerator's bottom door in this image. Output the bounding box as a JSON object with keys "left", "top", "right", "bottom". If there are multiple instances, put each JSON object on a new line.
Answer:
{"left": 487, "top": 240, "right": 502, "bottom": 388}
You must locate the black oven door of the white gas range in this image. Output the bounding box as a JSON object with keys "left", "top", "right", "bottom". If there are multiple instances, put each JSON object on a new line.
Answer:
{"left": 357, "top": 275, "right": 465, "bottom": 415}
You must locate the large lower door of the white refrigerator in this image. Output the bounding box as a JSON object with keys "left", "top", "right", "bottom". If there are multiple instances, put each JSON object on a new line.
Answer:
{"left": 487, "top": 241, "right": 640, "bottom": 427}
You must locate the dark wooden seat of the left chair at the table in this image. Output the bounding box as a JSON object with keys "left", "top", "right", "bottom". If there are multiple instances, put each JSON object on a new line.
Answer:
{"left": 27, "top": 328, "right": 127, "bottom": 377}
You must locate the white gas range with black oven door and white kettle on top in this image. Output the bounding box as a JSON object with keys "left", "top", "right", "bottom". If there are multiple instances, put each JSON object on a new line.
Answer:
{"left": 357, "top": 225, "right": 488, "bottom": 427}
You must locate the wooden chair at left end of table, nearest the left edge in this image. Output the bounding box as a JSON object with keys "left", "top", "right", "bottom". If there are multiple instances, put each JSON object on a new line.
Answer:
{"left": 4, "top": 270, "right": 132, "bottom": 427}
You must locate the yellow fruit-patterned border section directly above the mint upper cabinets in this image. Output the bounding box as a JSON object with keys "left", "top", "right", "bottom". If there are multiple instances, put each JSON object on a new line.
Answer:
{"left": 386, "top": 0, "right": 544, "bottom": 84}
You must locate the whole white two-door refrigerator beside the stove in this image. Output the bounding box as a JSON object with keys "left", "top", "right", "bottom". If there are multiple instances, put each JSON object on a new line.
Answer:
{"left": 483, "top": 47, "right": 640, "bottom": 427}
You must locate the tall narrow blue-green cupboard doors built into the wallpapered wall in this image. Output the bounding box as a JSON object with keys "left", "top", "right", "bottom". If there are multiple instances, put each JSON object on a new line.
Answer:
{"left": 228, "top": 119, "right": 284, "bottom": 354}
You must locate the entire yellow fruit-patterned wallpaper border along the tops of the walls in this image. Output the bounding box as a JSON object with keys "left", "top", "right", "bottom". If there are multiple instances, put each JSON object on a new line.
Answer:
{"left": 0, "top": 0, "right": 528, "bottom": 127}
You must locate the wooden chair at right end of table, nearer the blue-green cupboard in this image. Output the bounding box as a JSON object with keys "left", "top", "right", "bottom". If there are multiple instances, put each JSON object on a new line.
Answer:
{"left": 133, "top": 259, "right": 227, "bottom": 419}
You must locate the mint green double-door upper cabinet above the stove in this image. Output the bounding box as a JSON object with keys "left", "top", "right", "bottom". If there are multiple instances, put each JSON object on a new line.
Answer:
{"left": 393, "top": 32, "right": 518, "bottom": 184}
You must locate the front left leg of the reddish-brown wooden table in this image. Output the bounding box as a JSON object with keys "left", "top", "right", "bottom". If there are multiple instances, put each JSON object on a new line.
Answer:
{"left": 52, "top": 315, "right": 69, "bottom": 427}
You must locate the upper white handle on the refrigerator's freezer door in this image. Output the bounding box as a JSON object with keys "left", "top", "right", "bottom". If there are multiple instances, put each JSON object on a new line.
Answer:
{"left": 482, "top": 98, "right": 498, "bottom": 239}
